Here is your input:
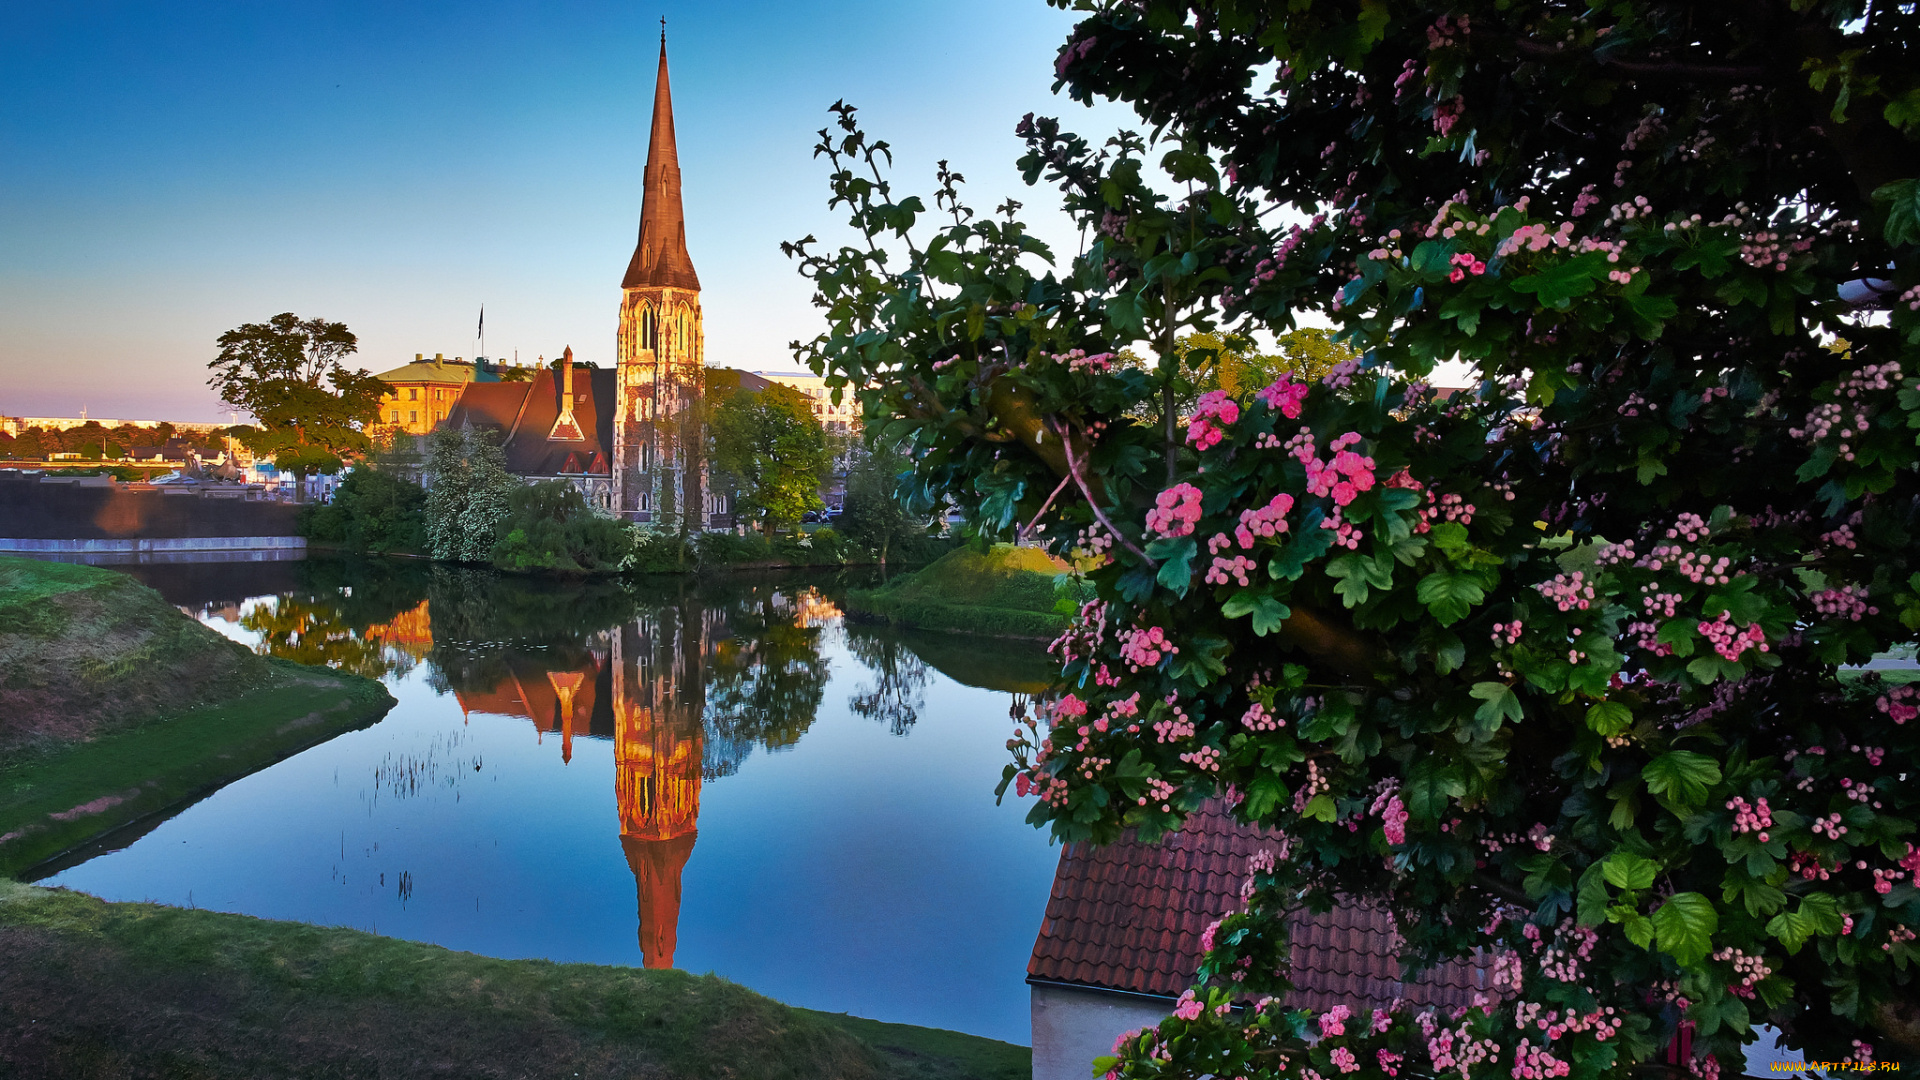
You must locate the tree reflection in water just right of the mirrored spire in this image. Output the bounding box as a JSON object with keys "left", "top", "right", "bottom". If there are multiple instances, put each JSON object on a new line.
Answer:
{"left": 707, "top": 586, "right": 828, "bottom": 753}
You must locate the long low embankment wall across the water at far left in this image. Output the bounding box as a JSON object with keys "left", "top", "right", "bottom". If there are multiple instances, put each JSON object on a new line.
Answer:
{"left": 0, "top": 477, "right": 307, "bottom": 557}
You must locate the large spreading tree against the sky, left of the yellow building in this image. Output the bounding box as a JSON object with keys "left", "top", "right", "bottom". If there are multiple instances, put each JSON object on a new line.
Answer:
{"left": 207, "top": 311, "right": 390, "bottom": 492}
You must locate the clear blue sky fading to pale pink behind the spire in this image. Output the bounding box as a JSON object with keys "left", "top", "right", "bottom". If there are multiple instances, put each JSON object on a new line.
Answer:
{"left": 0, "top": 0, "right": 1127, "bottom": 421}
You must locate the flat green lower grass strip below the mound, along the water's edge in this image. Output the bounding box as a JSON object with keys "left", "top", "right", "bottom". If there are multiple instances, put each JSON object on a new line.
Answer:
{"left": 0, "top": 657, "right": 394, "bottom": 876}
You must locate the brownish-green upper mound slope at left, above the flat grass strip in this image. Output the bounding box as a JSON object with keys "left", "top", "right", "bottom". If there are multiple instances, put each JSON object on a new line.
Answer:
{"left": 0, "top": 557, "right": 269, "bottom": 763}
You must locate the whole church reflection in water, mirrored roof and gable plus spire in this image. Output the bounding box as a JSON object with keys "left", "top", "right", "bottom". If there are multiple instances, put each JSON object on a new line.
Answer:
{"left": 455, "top": 607, "right": 726, "bottom": 969}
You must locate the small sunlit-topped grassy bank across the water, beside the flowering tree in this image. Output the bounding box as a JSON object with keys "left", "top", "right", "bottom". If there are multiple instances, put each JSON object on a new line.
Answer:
{"left": 847, "top": 544, "right": 1077, "bottom": 638}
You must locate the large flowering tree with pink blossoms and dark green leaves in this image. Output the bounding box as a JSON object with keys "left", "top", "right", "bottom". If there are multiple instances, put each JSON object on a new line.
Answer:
{"left": 789, "top": 0, "right": 1920, "bottom": 1080}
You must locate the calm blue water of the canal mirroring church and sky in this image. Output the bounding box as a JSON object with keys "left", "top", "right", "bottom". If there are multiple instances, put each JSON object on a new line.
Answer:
{"left": 42, "top": 559, "right": 1058, "bottom": 1043}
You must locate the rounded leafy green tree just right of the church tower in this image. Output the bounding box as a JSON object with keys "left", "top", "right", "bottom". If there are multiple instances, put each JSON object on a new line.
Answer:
{"left": 710, "top": 384, "right": 833, "bottom": 536}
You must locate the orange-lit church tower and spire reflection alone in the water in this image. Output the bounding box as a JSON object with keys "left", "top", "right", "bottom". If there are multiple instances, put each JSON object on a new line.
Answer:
{"left": 612, "top": 609, "right": 707, "bottom": 967}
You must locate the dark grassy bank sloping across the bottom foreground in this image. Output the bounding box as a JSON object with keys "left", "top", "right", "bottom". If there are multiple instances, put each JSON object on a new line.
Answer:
{"left": 0, "top": 882, "right": 1031, "bottom": 1080}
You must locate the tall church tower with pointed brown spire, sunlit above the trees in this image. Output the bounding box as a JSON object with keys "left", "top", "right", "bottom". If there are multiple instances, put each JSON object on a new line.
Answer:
{"left": 612, "top": 25, "right": 712, "bottom": 530}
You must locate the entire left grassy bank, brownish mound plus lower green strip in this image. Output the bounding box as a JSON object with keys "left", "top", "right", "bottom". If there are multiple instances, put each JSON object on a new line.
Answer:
{"left": 0, "top": 559, "right": 394, "bottom": 876}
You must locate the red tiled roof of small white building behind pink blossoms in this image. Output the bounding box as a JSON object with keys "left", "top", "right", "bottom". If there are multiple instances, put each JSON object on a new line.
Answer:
{"left": 1027, "top": 799, "right": 1488, "bottom": 1009}
